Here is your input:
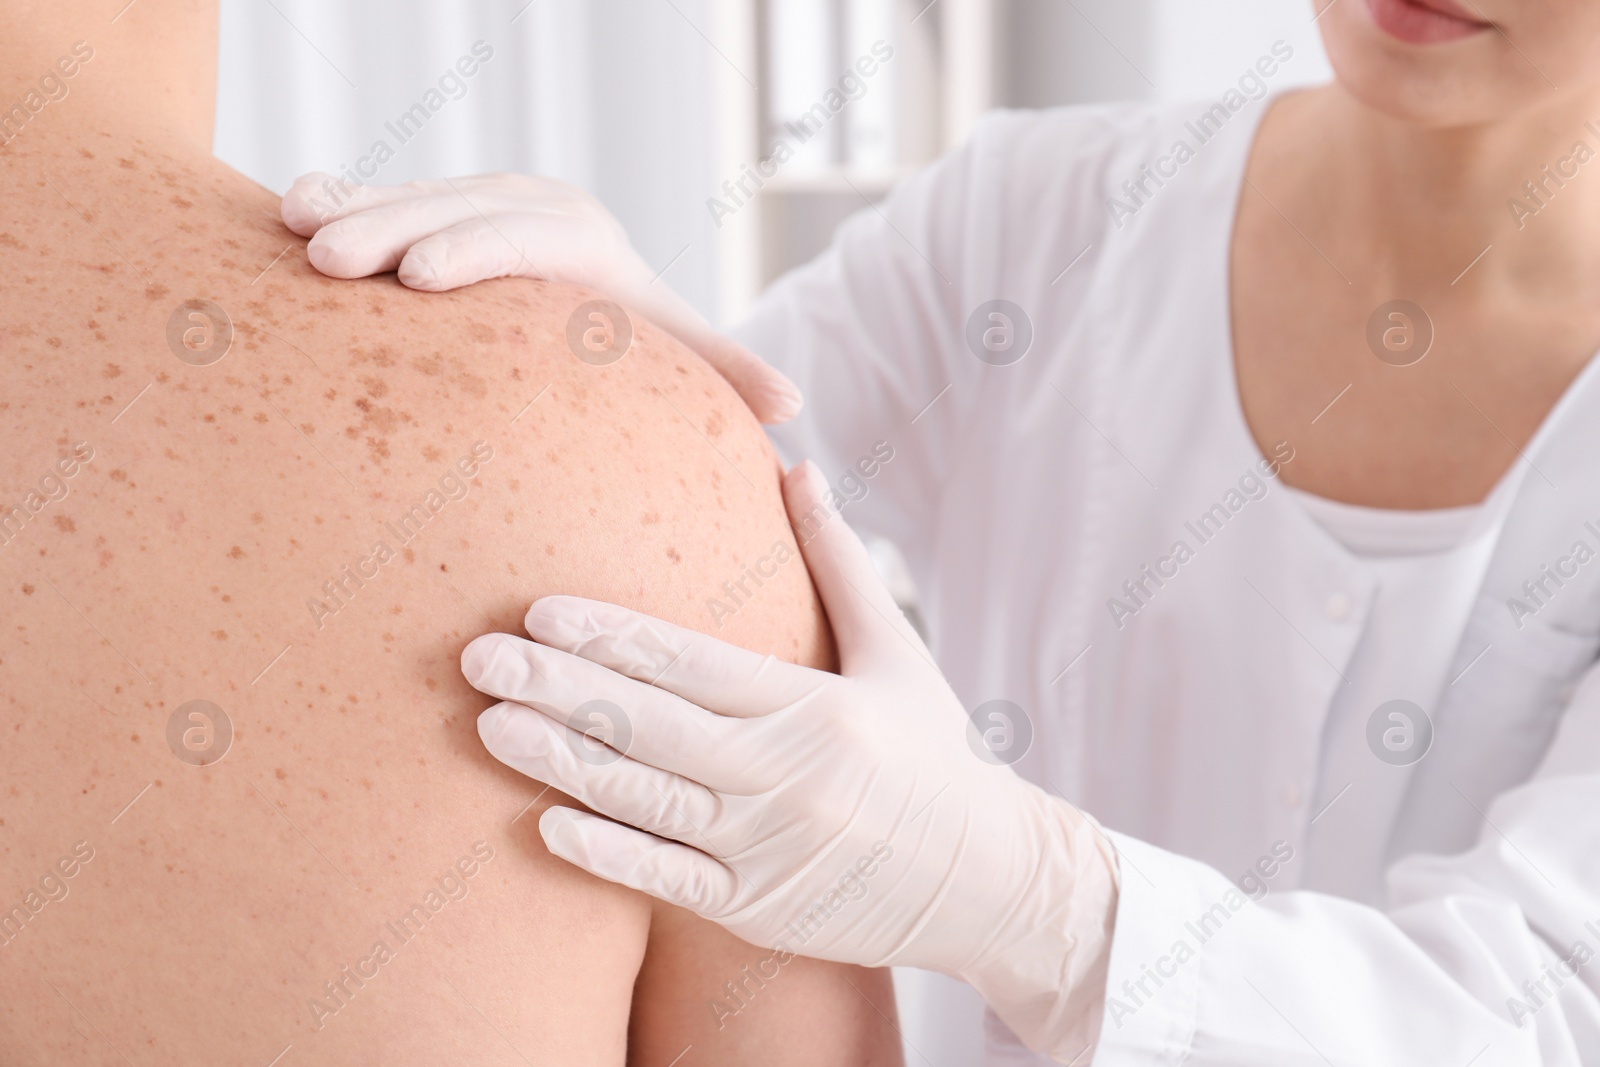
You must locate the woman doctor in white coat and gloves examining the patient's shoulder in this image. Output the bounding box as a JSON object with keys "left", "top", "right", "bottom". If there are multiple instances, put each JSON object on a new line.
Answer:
{"left": 285, "top": 0, "right": 1600, "bottom": 1067}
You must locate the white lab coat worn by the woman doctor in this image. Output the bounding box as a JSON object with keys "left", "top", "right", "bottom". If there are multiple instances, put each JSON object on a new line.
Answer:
{"left": 739, "top": 95, "right": 1600, "bottom": 1067}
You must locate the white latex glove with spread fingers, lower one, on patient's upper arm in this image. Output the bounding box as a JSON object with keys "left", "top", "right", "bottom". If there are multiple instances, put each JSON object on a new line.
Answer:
{"left": 461, "top": 464, "right": 1117, "bottom": 1062}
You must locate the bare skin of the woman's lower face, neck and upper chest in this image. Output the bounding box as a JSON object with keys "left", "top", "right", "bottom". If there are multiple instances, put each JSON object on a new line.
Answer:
{"left": 1232, "top": 0, "right": 1600, "bottom": 509}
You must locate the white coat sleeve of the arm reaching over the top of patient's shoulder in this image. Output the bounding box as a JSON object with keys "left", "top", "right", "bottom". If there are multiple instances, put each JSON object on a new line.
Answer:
{"left": 734, "top": 136, "right": 976, "bottom": 544}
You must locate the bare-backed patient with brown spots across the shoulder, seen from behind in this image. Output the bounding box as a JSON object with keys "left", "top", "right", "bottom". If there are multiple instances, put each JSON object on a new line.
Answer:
{"left": 0, "top": 0, "right": 899, "bottom": 1067}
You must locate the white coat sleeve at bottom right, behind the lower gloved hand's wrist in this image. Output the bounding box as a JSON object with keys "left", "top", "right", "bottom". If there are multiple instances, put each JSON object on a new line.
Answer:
{"left": 1094, "top": 670, "right": 1600, "bottom": 1067}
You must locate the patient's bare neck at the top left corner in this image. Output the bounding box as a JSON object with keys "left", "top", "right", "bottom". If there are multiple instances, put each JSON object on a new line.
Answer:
{"left": 0, "top": 0, "right": 218, "bottom": 155}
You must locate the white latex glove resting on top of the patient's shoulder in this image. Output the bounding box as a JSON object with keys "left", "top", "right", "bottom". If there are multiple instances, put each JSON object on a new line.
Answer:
{"left": 282, "top": 171, "right": 802, "bottom": 422}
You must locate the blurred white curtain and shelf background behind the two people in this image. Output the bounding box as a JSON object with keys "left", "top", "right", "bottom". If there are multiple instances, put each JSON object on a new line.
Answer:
{"left": 216, "top": 0, "right": 1328, "bottom": 1067}
